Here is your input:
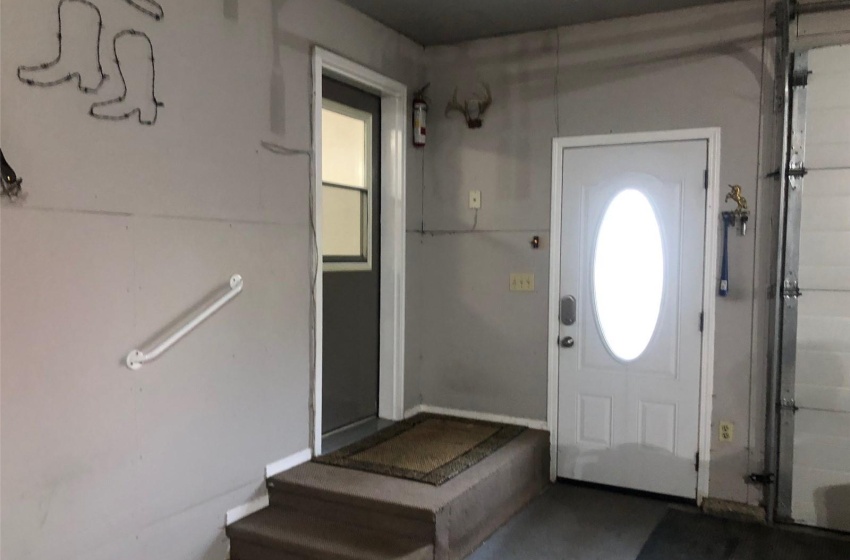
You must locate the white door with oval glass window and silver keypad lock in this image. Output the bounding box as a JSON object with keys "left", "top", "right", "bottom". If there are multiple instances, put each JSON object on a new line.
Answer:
{"left": 553, "top": 141, "right": 708, "bottom": 498}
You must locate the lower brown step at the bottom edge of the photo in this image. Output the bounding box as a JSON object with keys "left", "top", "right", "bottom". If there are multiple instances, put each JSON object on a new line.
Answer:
{"left": 227, "top": 507, "right": 434, "bottom": 560}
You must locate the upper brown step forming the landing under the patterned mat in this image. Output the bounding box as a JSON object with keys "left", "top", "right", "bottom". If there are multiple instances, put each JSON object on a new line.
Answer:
{"left": 264, "top": 430, "right": 549, "bottom": 560}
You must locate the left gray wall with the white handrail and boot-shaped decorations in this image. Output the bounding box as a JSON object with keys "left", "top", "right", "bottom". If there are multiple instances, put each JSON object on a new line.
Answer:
{"left": 0, "top": 0, "right": 422, "bottom": 560}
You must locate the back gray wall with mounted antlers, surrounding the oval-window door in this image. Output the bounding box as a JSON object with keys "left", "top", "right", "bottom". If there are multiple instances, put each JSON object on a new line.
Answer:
{"left": 414, "top": 1, "right": 775, "bottom": 501}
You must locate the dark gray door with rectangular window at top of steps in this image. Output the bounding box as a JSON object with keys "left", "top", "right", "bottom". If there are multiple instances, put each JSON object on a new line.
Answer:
{"left": 321, "top": 76, "right": 381, "bottom": 446}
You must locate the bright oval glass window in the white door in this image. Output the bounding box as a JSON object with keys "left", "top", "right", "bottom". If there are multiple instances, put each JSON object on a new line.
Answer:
{"left": 593, "top": 189, "right": 664, "bottom": 362}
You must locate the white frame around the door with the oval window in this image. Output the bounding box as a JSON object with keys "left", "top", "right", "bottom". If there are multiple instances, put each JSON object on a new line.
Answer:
{"left": 547, "top": 128, "right": 720, "bottom": 504}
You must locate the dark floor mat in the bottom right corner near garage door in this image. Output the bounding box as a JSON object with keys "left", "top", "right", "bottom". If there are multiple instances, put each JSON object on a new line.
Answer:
{"left": 637, "top": 509, "right": 850, "bottom": 560}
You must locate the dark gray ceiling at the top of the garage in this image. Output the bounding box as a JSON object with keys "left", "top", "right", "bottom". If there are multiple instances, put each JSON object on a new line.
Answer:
{"left": 342, "top": 0, "right": 724, "bottom": 46}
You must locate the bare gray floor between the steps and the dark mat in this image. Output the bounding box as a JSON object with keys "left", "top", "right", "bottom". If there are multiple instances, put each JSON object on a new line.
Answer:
{"left": 468, "top": 483, "right": 680, "bottom": 560}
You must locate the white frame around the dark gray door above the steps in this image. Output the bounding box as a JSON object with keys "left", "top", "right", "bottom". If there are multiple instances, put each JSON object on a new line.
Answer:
{"left": 310, "top": 47, "right": 407, "bottom": 455}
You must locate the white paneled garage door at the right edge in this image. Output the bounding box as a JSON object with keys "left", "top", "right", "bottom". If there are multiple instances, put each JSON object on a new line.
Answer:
{"left": 788, "top": 46, "right": 850, "bottom": 531}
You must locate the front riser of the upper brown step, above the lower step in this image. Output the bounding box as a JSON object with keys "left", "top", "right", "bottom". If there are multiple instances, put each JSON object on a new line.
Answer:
{"left": 269, "top": 483, "right": 434, "bottom": 542}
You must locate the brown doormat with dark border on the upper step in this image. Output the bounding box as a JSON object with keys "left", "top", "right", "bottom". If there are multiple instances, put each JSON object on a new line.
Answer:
{"left": 313, "top": 414, "right": 525, "bottom": 486}
